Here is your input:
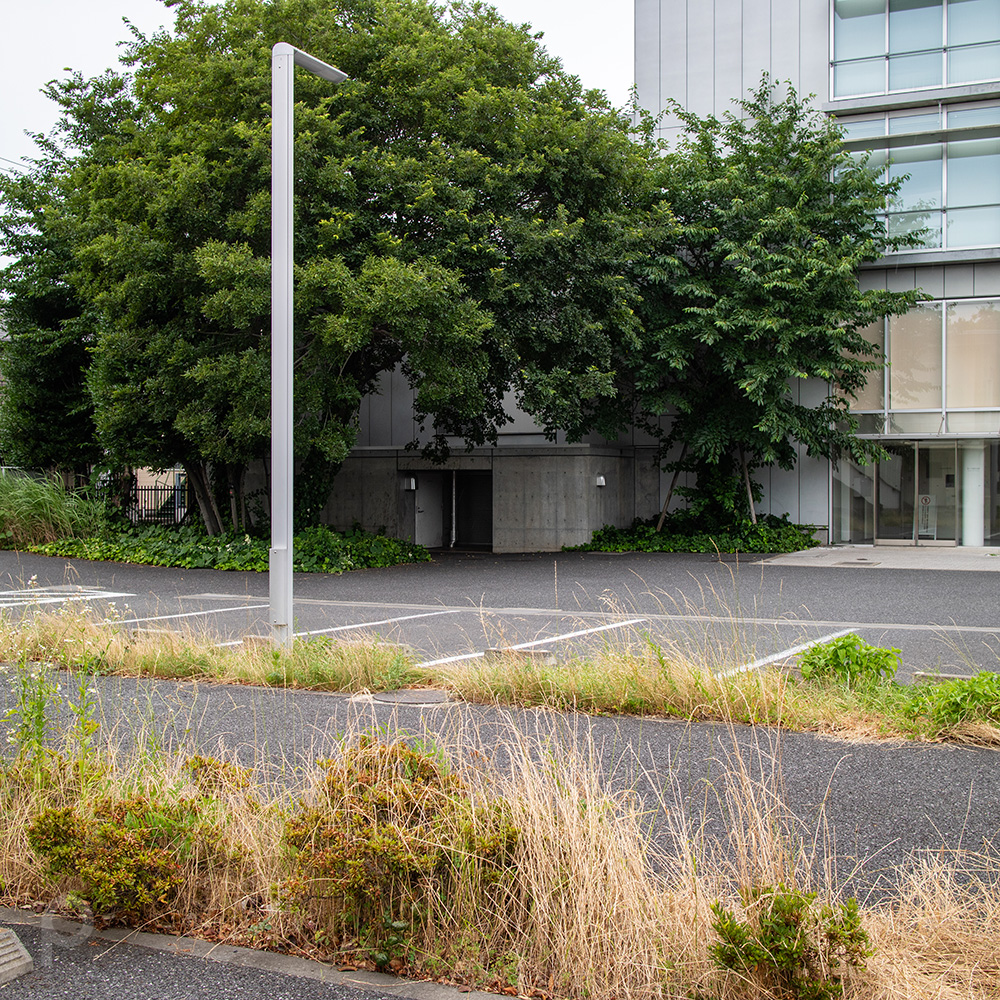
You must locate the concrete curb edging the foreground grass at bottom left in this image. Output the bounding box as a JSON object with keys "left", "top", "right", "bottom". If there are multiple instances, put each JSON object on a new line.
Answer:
{"left": 0, "top": 907, "right": 497, "bottom": 1000}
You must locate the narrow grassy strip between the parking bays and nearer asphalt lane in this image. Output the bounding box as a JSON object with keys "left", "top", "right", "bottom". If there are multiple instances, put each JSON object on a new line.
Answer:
{"left": 0, "top": 605, "right": 1000, "bottom": 746}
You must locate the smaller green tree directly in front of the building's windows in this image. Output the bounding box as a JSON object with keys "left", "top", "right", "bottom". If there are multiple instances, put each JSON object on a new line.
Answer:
{"left": 627, "top": 77, "right": 921, "bottom": 516}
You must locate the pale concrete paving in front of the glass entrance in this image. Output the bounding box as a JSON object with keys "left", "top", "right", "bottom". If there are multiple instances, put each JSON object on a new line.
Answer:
{"left": 767, "top": 545, "right": 1000, "bottom": 573}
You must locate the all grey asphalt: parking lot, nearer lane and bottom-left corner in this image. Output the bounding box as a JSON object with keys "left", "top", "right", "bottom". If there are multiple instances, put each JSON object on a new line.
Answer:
{"left": 0, "top": 550, "right": 1000, "bottom": 1000}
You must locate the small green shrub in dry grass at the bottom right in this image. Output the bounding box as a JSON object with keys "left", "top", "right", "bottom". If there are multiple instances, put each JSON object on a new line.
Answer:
{"left": 709, "top": 884, "right": 871, "bottom": 1000}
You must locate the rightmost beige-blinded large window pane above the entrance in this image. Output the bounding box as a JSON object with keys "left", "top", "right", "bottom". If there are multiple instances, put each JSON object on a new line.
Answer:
{"left": 947, "top": 302, "right": 1000, "bottom": 409}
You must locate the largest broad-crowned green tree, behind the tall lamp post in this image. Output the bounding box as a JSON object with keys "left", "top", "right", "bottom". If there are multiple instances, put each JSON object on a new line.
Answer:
{"left": 11, "top": 0, "right": 650, "bottom": 531}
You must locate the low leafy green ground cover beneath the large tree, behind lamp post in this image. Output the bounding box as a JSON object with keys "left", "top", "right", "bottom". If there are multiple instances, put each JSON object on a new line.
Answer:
{"left": 31, "top": 525, "right": 430, "bottom": 573}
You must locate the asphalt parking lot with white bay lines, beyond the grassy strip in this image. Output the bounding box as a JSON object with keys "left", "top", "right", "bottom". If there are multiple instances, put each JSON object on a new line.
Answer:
{"left": 0, "top": 549, "right": 1000, "bottom": 680}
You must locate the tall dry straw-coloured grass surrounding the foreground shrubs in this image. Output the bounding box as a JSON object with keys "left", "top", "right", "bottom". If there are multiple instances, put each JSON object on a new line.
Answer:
{"left": 0, "top": 708, "right": 1000, "bottom": 1000}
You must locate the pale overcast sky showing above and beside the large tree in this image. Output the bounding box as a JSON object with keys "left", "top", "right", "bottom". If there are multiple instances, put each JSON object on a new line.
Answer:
{"left": 0, "top": 0, "right": 633, "bottom": 175}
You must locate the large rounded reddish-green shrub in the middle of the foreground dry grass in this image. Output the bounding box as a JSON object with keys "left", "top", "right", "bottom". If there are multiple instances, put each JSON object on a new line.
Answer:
{"left": 281, "top": 737, "right": 518, "bottom": 964}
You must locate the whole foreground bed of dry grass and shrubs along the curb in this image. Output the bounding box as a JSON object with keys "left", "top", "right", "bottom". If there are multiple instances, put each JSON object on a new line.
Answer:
{"left": 0, "top": 664, "right": 1000, "bottom": 1000}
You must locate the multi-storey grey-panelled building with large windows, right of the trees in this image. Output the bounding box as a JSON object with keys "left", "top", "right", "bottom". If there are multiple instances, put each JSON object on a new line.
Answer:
{"left": 635, "top": 0, "right": 1000, "bottom": 545}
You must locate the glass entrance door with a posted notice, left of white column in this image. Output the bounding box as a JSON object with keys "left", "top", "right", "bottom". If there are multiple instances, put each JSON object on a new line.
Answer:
{"left": 875, "top": 441, "right": 958, "bottom": 545}
